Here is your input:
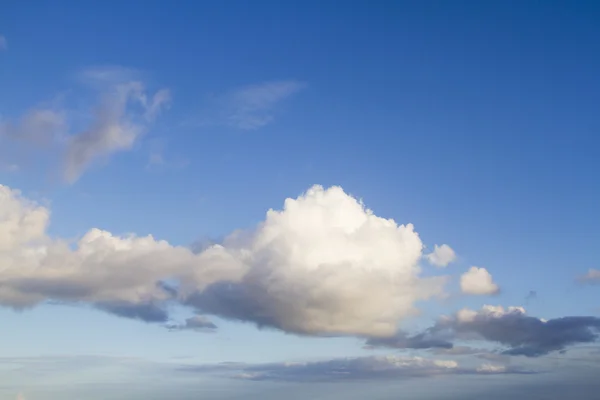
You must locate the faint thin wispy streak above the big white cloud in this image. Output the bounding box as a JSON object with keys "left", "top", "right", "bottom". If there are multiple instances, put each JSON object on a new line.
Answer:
{"left": 192, "top": 80, "right": 306, "bottom": 130}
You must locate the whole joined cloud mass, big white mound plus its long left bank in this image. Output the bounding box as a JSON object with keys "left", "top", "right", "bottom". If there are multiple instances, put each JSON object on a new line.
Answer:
{"left": 0, "top": 186, "right": 446, "bottom": 336}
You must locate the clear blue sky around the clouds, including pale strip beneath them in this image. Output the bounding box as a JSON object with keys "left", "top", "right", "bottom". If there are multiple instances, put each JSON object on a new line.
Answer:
{"left": 0, "top": 0, "right": 600, "bottom": 399}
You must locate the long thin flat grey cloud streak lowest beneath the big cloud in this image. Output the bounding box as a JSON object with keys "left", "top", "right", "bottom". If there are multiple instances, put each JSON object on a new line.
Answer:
{"left": 182, "top": 355, "right": 524, "bottom": 382}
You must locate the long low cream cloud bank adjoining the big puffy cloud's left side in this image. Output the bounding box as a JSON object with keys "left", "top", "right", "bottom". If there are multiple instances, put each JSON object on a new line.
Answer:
{"left": 0, "top": 186, "right": 240, "bottom": 321}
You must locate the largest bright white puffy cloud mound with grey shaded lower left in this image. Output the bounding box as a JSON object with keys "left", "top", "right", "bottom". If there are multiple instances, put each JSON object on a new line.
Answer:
{"left": 188, "top": 186, "right": 445, "bottom": 336}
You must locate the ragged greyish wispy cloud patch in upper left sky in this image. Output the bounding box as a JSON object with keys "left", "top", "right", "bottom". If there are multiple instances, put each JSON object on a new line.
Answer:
{"left": 0, "top": 67, "right": 171, "bottom": 183}
